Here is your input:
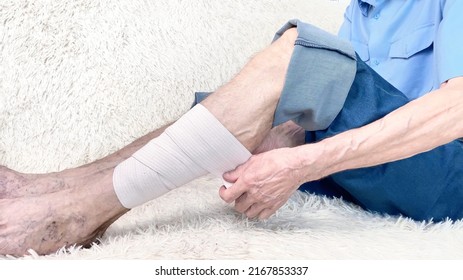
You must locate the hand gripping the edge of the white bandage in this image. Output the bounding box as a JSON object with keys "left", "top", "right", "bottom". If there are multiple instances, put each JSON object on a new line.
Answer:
{"left": 219, "top": 148, "right": 304, "bottom": 219}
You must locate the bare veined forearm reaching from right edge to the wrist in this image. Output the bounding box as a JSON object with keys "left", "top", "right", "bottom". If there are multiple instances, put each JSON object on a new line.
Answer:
{"left": 297, "top": 78, "right": 463, "bottom": 180}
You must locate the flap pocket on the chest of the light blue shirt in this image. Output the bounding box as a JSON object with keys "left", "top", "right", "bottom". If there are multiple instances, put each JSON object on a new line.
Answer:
{"left": 389, "top": 23, "right": 436, "bottom": 59}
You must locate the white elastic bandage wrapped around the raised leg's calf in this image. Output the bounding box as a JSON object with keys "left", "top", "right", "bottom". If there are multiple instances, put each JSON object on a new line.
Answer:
{"left": 113, "top": 104, "right": 251, "bottom": 208}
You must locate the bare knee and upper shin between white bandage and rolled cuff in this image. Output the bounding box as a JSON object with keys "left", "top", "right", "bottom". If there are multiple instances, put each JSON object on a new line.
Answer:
{"left": 201, "top": 28, "right": 297, "bottom": 151}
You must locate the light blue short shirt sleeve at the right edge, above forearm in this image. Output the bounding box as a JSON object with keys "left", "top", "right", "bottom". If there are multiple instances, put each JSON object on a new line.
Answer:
{"left": 434, "top": 0, "right": 463, "bottom": 83}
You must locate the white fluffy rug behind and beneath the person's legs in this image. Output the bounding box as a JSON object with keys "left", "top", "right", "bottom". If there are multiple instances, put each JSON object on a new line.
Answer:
{"left": 0, "top": 0, "right": 463, "bottom": 259}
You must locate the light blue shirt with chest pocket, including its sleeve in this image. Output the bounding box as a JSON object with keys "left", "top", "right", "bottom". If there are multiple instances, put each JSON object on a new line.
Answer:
{"left": 338, "top": 0, "right": 463, "bottom": 99}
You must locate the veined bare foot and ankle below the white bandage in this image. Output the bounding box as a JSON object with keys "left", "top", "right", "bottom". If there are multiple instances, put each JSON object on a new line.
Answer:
{"left": 0, "top": 169, "right": 128, "bottom": 256}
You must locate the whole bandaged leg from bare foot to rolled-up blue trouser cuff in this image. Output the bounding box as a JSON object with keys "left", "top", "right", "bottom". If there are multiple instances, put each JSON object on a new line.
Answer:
{"left": 0, "top": 17, "right": 362, "bottom": 255}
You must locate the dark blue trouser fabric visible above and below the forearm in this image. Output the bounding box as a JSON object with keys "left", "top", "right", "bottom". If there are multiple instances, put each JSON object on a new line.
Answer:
{"left": 314, "top": 59, "right": 463, "bottom": 220}
